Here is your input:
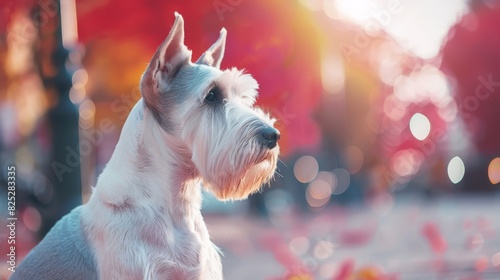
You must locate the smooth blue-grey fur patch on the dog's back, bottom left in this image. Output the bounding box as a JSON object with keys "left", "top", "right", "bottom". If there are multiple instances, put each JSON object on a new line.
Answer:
{"left": 10, "top": 206, "right": 98, "bottom": 280}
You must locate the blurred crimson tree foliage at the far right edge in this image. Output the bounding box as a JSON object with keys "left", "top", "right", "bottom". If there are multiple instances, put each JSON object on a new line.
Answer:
{"left": 442, "top": 4, "right": 500, "bottom": 153}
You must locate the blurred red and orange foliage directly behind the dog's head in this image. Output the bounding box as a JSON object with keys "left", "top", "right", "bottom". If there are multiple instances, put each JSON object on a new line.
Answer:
{"left": 77, "top": 0, "right": 322, "bottom": 151}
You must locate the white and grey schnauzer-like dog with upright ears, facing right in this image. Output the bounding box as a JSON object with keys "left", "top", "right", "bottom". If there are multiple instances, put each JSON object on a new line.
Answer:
{"left": 11, "top": 13, "right": 279, "bottom": 280}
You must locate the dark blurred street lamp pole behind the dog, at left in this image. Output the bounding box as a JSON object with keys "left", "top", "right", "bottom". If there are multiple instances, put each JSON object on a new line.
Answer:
{"left": 40, "top": 0, "right": 82, "bottom": 235}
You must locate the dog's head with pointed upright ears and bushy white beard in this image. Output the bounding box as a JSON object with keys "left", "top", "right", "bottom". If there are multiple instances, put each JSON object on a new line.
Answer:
{"left": 141, "top": 13, "right": 280, "bottom": 200}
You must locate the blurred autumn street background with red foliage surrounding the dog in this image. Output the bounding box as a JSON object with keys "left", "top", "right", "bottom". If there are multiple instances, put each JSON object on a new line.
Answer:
{"left": 0, "top": 0, "right": 500, "bottom": 280}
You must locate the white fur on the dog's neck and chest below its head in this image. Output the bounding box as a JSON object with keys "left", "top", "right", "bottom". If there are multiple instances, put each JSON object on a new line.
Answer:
{"left": 82, "top": 100, "right": 222, "bottom": 279}
